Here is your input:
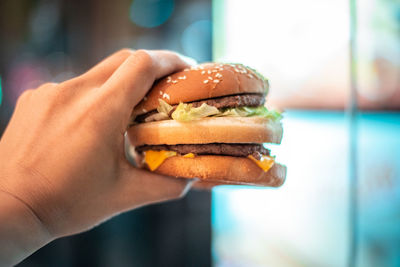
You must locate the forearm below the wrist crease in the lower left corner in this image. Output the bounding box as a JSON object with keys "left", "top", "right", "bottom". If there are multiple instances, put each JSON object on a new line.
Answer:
{"left": 0, "top": 190, "right": 51, "bottom": 266}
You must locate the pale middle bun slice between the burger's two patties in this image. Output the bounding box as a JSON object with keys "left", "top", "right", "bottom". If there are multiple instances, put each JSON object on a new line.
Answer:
{"left": 128, "top": 117, "right": 283, "bottom": 146}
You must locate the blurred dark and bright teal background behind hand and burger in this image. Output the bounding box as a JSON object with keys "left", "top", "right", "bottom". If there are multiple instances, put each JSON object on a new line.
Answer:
{"left": 0, "top": 0, "right": 400, "bottom": 267}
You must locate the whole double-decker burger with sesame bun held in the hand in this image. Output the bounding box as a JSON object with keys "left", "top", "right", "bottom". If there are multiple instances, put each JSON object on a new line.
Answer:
{"left": 128, "top": 63, "right": 286, "bottom": 187}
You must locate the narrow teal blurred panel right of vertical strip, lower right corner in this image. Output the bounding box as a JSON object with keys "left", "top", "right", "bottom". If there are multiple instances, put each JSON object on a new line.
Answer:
{"left": 358, "top": 112, "right": 400, "bottom": 267}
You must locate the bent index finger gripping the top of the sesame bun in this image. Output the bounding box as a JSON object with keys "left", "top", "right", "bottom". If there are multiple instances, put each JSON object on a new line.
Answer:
{"left": 103, "top": 50, "right": 192, "bottom": 108}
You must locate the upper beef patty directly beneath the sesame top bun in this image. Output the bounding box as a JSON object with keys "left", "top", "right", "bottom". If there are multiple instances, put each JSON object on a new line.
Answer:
{"left": 135, "top": 94, "right": 265, "bottom": 122}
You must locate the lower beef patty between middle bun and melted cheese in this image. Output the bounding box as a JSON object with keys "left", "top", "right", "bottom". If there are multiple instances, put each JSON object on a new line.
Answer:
{"left": 136, "top": 143, "right": 270, "bottom": 159}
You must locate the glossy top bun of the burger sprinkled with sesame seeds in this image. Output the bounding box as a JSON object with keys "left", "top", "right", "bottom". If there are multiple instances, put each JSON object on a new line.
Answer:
{"left": 132, "top": 63, "right": 268, "bottom": 116}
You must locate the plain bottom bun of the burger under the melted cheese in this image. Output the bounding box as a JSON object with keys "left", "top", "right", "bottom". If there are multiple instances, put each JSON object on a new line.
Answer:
{"left": 138, "top": 155, "right": 286, "bottom": 187}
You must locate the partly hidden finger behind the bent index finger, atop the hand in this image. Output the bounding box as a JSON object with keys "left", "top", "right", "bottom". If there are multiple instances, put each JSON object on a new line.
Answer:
{"left": 81, "top": 48, "right": 134, "bottom": 85}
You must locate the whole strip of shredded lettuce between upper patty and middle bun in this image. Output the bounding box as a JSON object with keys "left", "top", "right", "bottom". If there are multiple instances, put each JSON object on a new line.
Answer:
{"left": 155, "top": 99, "right": 282, "bottom": 121}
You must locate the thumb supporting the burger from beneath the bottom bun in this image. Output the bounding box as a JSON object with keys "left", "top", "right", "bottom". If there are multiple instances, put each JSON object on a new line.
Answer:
{"left": 109, "top": 166, "right": 193, "bottom": 212}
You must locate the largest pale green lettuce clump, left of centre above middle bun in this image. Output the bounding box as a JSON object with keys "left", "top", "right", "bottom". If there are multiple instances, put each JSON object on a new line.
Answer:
{"left": 171, "top": 103, "right": 220, "bottom": 121}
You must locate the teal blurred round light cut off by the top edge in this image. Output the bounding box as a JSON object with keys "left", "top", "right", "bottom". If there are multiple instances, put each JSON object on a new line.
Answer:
{"left": 130, "top": 0, "right": 174, "bottom": 28}
